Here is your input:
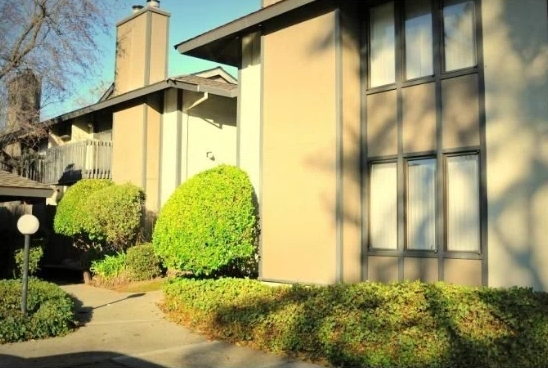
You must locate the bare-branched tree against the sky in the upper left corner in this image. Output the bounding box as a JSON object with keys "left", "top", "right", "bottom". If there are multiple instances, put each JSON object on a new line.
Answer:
{"left": 0, "top": 0, "right": 123, "bottom": 175}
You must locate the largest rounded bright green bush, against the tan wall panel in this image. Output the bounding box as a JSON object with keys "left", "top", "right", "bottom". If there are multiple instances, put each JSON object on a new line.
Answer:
{"left": 153, "top": 165, "right": 258, "bottom": 275}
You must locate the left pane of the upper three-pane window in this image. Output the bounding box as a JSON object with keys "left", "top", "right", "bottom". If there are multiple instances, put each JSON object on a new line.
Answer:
{"left": 370, "top": 2, "right": 396, "bottom": 87}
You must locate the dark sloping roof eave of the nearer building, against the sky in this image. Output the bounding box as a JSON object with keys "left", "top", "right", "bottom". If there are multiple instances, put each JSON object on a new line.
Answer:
{"left": 174, "top": 0, "right": 318, "bottom": 67}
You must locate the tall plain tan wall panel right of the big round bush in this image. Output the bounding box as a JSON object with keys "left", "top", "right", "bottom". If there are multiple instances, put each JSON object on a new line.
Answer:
{"left": 260, "top": 13, "right": 337, "bottom": 283}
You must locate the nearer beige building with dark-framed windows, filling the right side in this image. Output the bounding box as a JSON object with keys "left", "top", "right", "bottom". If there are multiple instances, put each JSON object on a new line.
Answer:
{"left": 175, "top": 0, "right": 548, "bottom": 290}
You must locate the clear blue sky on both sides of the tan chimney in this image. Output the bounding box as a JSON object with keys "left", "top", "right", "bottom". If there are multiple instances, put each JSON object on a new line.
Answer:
{"left": 43, "top": 0, "right": 261, "bottom": 118}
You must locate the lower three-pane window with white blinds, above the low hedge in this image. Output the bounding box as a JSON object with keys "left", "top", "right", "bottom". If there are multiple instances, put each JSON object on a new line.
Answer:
{"left": 369, "top": 154, "right": 480, "bottom": 252}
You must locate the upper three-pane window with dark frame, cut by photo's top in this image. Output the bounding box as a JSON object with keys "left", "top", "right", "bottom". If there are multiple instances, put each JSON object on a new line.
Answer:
{"left": 369, "top": 0, "right": 477, "bottom": 88}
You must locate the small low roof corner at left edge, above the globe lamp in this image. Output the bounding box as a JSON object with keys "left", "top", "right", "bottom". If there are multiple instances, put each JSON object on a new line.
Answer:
{"left": 0, "top": 170, "right": 53, "bottom": 202}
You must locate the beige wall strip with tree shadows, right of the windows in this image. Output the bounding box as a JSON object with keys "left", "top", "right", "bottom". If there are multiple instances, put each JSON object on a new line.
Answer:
{"left": 482, "top": 0, "right": 548, "bottom": 290}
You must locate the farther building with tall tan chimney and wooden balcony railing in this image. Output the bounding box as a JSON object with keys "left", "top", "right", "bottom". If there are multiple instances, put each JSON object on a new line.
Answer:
{"left": 2, "top": 1, "right": 238, "bottom": 214}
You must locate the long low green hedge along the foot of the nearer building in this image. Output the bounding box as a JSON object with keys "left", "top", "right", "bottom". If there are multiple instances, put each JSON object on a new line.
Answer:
{"left": 163, "top": 279, "right": 548, "bottom": 367}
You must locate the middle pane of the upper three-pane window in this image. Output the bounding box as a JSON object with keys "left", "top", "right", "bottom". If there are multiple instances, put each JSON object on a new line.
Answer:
{"left": 405, "top": 0, "right": 434, "bottom": 79}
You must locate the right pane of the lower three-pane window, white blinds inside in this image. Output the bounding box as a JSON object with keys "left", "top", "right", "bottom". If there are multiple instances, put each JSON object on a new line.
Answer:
{"left": 447, "top": 155, "right": 480, "bottom": 252}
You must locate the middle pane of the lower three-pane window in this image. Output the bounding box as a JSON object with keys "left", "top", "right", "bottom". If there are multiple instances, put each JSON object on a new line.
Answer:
{"left": 407, "top": 159, "right": 436, "bottom": 250}
